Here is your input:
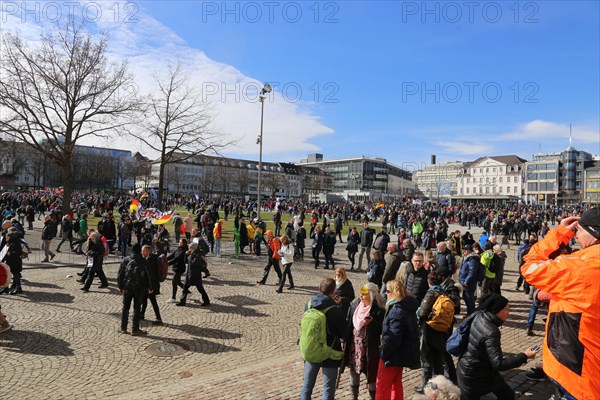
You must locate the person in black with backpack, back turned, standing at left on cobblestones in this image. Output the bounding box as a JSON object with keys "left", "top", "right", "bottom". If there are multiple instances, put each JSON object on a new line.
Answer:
{"left": 117, "top": 243, "right": 148, "bottom": 336}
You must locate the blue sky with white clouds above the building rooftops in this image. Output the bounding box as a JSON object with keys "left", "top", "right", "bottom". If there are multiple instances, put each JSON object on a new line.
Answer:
{"left": 2, "top": 1, "right": 600, "bottom": 165}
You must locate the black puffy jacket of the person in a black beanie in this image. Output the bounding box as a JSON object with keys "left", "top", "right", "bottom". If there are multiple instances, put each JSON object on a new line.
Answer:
{"left": 457, "top": 311, "right": 527, "bottom": 393}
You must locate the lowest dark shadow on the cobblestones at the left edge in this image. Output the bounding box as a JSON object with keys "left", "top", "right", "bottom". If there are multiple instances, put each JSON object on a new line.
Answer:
{"left": 0, "top": 329, "right": 74, "bottom": 356}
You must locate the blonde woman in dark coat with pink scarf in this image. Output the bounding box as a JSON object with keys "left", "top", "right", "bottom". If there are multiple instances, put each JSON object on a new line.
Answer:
{"left": 340, "top": 283, "right": 385, "bottom": 400}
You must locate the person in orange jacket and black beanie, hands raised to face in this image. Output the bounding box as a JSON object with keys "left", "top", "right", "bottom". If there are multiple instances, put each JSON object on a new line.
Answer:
{"left": 521, "top": 207, "right": 600, "bottom": 400}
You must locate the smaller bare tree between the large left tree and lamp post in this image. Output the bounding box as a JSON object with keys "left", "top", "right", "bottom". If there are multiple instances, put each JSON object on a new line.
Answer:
{"left": 131, "top": 63, "right": 229, "bottom": 205}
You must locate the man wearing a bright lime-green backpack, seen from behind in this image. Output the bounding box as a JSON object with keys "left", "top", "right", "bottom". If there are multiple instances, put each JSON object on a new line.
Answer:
{"left": 300, "top": 278, "right": 346, "bottom": 400}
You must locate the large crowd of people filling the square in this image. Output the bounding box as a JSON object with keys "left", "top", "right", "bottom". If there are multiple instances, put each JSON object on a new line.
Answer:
{"left": 0, "top": 191, "right": 600, "bottom": 400}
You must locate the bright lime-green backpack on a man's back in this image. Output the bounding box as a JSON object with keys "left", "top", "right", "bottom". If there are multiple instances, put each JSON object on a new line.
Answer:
{"left": 300, "top": 302, "right": 344, "bottom": 363}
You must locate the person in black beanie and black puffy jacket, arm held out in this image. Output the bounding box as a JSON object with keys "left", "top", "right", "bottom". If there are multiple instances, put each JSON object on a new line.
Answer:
{"left": 457, "top": 293, "right": 545, "bottom": 400}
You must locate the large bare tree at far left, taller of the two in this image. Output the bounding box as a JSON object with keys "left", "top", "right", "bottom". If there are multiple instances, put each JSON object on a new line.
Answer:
{"left": 0, "top": 20, "right": 138, "bottom": 210}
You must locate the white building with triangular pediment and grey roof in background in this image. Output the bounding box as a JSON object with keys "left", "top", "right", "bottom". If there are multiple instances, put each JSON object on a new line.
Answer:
{"left": 456, "top": 155, "right": 526, "bottom": 204}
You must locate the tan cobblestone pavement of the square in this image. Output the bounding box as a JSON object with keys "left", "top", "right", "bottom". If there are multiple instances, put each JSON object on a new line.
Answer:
{"left": 0, "top": 221, "right": 551, "bottom": 399}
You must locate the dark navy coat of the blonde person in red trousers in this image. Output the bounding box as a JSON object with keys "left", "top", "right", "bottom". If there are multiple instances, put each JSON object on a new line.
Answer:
{"left": 379, "top": 296, "right": 420, "bottom": 368}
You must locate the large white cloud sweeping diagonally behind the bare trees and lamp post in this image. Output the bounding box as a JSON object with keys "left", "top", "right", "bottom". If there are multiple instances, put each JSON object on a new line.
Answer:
{"left": 0, "top": 2, "right": 333, "bottom": 160}
